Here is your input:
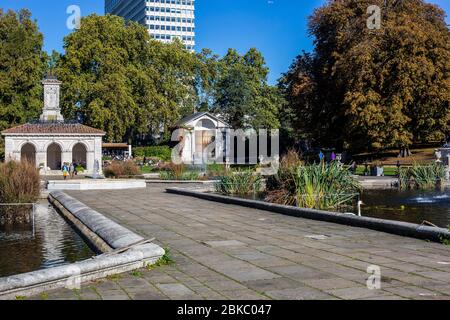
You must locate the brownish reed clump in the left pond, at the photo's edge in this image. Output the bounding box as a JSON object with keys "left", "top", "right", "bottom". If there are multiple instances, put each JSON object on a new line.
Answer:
{"left": 0, "top": 161, "right": 41, "bottom": 223}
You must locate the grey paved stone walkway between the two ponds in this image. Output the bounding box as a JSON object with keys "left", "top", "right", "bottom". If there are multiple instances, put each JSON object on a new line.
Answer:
{"left": 29, "top": 186, "right": 450, "bottom": 300}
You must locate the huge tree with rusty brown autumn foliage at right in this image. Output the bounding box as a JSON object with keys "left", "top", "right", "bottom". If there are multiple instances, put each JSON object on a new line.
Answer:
{"left": 280, "top": 0, "right": 450, "bottom": 150}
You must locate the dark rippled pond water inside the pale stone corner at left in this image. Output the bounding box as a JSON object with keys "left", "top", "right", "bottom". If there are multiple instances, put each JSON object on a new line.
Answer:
{"left": 0, "top": 201, "right": 95, "bottom": 277}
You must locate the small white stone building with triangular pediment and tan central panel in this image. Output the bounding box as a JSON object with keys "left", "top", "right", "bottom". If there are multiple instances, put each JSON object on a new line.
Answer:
{"left": 176, "top": 112, "right": 230, "bottom": 164}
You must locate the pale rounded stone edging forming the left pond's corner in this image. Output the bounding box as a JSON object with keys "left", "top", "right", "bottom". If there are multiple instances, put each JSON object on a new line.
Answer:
{"left": 0, "top": 191, "right": 165, "bottom": 300}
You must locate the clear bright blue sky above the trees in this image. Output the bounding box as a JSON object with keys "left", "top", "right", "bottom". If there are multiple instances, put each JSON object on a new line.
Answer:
{"left": 0, "top": 0, "right": 450, "bottom": 83}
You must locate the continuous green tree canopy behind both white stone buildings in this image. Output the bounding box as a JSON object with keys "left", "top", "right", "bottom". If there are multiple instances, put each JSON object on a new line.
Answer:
{"left": 0, "top": 10, "right": 282, "bottom": 150}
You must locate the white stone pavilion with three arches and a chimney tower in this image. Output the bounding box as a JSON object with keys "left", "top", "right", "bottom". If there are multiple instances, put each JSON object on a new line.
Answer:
{"left": 1, "top": 78, "right": 105, "bottom": 175}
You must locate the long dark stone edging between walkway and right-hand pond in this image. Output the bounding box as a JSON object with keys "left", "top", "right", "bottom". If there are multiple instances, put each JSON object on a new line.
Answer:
{"left": 166, "top": 188, "right": 450, "bottom": 242}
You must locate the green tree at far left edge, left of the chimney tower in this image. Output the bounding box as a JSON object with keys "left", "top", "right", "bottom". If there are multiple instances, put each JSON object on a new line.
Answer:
{"left": 0, "top": 9, "right": 47, "bottom": 157}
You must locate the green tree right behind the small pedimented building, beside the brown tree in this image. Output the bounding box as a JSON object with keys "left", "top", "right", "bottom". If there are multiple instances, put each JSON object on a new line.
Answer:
{"left": 212, "top": 49, "right": 282, "bottom": 129}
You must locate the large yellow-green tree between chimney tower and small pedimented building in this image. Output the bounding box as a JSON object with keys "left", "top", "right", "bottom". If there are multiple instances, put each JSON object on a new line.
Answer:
{"left": 57, "top": 15, "right": 197, "bottom": 142}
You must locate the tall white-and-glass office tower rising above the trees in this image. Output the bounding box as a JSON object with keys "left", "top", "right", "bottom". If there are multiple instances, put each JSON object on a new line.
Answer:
{"left": 105, "top": 0, "right": 195, "bottom": 50}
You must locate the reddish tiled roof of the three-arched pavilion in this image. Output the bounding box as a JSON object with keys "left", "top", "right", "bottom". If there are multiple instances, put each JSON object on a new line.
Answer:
{"left": 2, "top": 123, "right": 105, "bottom": 135}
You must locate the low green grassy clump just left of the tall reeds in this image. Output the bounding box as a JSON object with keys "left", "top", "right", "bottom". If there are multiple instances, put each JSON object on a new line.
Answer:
{"left": 215, "top": 170, "right": 262, "bottom": 196}
